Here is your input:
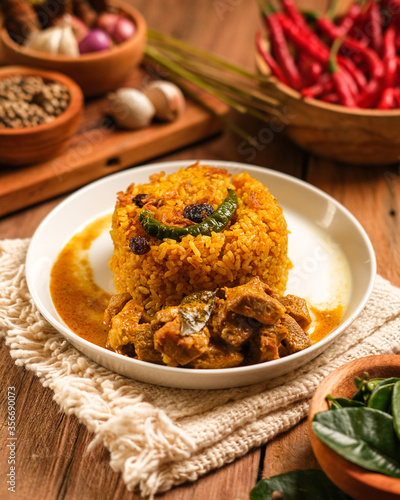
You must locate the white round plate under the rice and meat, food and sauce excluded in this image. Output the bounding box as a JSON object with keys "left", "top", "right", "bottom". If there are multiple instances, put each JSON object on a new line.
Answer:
{"left": 26, "top": 160, "right": 376, "bottom": 389}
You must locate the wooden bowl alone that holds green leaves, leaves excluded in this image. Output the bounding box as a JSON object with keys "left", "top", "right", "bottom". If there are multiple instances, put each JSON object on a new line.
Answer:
{"left": 308, "top": 355, "right": 400, "bottom": 500}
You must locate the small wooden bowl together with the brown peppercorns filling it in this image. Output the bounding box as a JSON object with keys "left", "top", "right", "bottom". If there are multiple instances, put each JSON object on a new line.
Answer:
{"left": 0, "top": 66, "right": 83, "bottom": 167}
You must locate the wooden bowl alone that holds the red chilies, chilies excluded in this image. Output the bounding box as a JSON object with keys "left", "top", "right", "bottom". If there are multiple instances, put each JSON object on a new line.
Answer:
{"left": 256, "top": 49, "right": 400, "bottom": 165}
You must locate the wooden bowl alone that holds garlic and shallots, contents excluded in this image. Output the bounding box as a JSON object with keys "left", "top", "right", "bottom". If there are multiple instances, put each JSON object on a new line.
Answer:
{"left": 0, "top": 0, "right": 147, "bottom": 97}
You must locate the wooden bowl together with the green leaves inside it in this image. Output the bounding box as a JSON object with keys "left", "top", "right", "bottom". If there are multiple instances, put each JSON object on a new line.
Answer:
{"left": 308, "top": 355, "right": 400, "bottom": 500}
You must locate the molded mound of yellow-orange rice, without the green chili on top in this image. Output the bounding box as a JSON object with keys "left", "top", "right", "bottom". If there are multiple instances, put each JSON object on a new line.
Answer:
{"left": 109, "top": 163, "right": 291, "bottom": 316}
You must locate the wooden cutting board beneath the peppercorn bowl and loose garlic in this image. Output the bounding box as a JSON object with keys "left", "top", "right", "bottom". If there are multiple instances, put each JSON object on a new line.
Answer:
{"left": 0, "top": 64, "right": 228, "bottom": 216}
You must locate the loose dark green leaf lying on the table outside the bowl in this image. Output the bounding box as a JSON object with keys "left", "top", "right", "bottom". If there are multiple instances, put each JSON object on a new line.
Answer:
{"left": 250, "top": 469, "right": 350, "bottom": 500}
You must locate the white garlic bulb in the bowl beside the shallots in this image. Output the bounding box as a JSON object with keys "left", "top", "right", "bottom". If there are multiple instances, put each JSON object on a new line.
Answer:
{"left": 26, "top": 14, "right": 79, "bottom": 57}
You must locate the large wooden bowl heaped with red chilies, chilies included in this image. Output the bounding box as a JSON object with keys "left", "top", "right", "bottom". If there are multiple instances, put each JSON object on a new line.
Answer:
{"left": 256, "top": 0, "right": 400, "bottom": 165}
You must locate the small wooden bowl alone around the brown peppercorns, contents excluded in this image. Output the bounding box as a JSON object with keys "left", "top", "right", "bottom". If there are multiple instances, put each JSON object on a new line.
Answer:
{"left": 0, "top": 66, "right": 83, "bottom": 166}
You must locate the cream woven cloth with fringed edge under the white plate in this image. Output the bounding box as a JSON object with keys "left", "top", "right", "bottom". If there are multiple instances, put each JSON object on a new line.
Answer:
{"left": 0, "top": 240, "right": 400, "bottom": 496}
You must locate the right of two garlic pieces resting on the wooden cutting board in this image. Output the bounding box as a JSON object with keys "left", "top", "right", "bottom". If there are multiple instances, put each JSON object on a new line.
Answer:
{"left": 143, "top": 80, "right": 185, "bottom": 122}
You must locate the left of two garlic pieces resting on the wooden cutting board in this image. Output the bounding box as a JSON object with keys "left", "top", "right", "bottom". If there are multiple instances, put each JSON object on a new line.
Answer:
{"left": 108, "top": 88, "right": 156, "bottom": 129}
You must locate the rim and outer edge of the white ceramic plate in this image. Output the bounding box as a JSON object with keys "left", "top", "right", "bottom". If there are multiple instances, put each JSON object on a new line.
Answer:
{"left": 26, "top": 159, "right": 376, "bottom": 389}
